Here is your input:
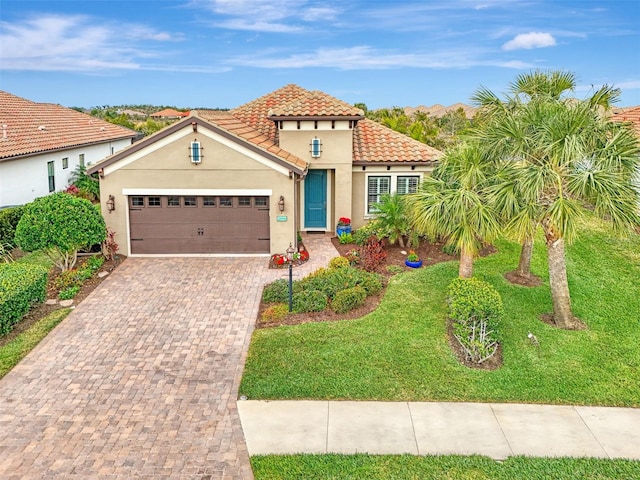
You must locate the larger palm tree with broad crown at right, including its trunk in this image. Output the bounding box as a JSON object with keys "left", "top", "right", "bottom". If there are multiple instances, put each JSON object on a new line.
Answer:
{"left": 475, "top": 72, "right": 640, "bottom": 328}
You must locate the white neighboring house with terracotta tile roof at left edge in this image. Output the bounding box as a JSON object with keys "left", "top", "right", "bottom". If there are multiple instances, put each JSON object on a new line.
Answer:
{"left": 0, "top": 90, "right": 137, "bottom": 208}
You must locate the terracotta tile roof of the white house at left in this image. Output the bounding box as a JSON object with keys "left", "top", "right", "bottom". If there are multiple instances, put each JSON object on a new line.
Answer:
{"left": 0, "top": 90, "right": 137, "bottom": 161}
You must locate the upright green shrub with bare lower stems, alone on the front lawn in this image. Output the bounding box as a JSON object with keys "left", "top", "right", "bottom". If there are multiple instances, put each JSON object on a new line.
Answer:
{"left": 448, "top": 278, "right": 504, "bottom": 364}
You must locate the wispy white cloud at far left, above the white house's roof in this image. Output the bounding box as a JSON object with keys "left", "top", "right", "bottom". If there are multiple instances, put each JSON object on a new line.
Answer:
{"left": 0, "top": 15, "right": 182, "bottom": 72}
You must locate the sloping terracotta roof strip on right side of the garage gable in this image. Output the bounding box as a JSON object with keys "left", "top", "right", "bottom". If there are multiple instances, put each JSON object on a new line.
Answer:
{"left": 199, "top": 110, "right": 309, "bottom": 171}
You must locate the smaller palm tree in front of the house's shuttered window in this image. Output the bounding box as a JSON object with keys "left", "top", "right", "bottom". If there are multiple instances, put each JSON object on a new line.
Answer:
{"left": 411, "top": 143, "right": 500, "bottom": 278}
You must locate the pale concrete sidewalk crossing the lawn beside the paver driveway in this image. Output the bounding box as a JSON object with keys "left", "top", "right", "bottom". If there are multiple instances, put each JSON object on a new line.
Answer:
{"left": 238, "top": 400, "right": 640, "bottom": 460}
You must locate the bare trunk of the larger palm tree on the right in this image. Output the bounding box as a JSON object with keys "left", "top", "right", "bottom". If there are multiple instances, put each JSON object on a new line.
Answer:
{"left": 545, "top": 230, "right": 576, "bottom": 329}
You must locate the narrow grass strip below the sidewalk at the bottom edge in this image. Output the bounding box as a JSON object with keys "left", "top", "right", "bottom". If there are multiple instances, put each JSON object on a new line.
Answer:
{"left": 251, "top": 455, "right": 640, "bottom": 480}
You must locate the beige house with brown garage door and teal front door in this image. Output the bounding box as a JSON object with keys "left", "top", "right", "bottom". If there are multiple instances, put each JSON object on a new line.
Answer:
{"left": 88, "top": 85, "right": 441, "bottom": 256}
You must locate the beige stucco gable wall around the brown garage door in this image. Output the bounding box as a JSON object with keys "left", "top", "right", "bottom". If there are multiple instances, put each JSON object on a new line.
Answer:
{"left": 100, "top": 125, "right": 296, "bottom": 255}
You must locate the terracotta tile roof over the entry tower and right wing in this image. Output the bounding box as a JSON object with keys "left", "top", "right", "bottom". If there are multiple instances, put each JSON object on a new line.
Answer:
{"left": 230, "top": 84, "right": 441, "bottom": 163}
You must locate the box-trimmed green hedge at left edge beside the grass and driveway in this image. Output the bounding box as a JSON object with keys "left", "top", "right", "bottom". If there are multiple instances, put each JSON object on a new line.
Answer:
{"left": 0, "top": 263, "right": 49, "bottom": 335}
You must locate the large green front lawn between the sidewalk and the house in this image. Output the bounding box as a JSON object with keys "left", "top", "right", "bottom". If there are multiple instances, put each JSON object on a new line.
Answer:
{"left": 240, "top": 221, "right": 640, "bottom": 407}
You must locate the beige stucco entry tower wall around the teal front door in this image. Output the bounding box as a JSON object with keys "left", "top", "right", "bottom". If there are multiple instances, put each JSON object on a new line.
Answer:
{"left": 279, "top": 120, "right": 353, "bottom": 231}
